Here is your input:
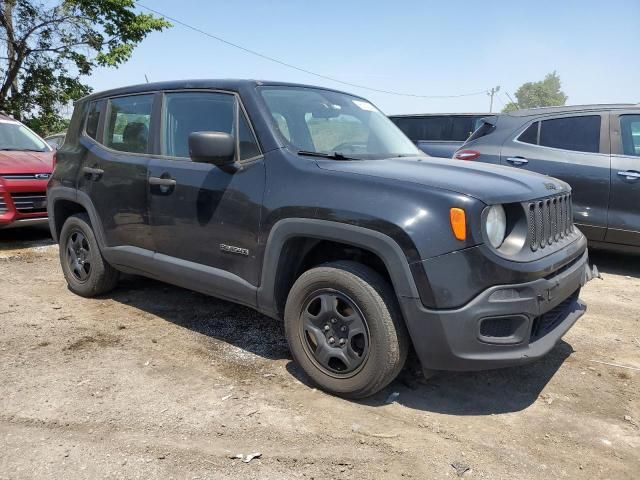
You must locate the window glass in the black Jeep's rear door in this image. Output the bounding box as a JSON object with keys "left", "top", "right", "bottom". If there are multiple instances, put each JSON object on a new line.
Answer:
{"left": 104, "top": 95, "right": 153, "bottom": 153}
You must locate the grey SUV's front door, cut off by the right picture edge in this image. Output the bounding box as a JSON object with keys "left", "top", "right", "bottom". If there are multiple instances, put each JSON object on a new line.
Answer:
{"left": 605, "top": 110, "right": 640, "bottom": 246}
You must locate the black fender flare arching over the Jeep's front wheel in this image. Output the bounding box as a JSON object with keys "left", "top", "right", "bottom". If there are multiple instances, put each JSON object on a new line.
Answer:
{"left": 257, "top": 218, "right": 420, "bottom": 317}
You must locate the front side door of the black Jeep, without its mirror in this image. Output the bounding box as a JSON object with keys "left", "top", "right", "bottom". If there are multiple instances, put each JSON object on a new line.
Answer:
{"left": 148, "top": 91, "right": 265, "bottom": 285}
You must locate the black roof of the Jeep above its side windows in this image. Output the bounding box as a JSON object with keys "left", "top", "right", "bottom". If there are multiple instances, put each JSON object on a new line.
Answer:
{"left": 80, "top": 79, "right": 361, "bottom": 101}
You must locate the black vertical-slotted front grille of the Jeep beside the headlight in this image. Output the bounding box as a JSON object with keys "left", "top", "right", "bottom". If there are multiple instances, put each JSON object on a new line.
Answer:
{"left": 527, "top": 193, "right": 574, "bottom": 252}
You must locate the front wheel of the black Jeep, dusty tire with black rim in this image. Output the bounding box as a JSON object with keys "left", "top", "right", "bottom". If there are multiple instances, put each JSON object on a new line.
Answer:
{"left": 284, "top": 261, "right": 409, "bottom": 398}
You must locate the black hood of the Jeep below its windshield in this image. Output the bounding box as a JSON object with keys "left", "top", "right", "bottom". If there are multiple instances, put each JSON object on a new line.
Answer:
{"left": 318, "top": 157, "right": 571, "bottom": 205}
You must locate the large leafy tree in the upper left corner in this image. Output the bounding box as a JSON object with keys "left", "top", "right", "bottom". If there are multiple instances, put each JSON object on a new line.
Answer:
{"left": 0, "top": 0, "right": 170, "bottom": 135}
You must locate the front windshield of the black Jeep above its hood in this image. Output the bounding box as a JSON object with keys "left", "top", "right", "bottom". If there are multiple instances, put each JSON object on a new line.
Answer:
{"left": 260, "top": 87, "right": 424, "bottom": 159}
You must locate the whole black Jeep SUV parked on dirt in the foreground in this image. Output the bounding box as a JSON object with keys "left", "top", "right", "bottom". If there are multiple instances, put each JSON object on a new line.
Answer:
{"left": 48, "top": 80, "right": 591, "bottom": 398}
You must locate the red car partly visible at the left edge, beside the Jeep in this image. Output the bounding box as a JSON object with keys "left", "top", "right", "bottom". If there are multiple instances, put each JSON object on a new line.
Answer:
{"left": 0, "top": 114, "right": 54, "bottom": 228}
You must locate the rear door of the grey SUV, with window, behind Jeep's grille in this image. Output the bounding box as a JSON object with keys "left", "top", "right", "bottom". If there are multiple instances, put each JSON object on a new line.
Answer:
{"left": 501, "top": 113, "right": 611, "bottom": 241}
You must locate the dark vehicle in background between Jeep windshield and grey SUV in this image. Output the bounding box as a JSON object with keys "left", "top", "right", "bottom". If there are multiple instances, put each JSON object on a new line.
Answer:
{"left": 389, "top": 113, "right": 493, "bottom": 158}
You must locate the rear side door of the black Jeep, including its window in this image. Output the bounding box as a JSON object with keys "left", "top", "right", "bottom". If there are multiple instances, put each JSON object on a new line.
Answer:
{"left": 78, "top": 94, "right": 154, "bottom": 250}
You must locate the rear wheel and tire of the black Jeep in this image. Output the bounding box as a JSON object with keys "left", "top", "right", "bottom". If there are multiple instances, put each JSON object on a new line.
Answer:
{"left": 60, "top": 213, "right": 119, "bottom": 297}
